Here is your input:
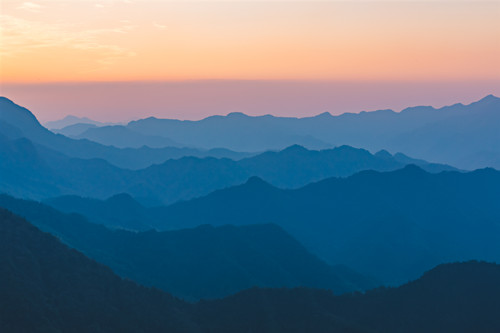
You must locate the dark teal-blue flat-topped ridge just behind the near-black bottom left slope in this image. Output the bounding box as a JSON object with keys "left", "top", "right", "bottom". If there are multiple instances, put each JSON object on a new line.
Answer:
{"left": 0, "top": 195, "right": 376, "bottom": 299}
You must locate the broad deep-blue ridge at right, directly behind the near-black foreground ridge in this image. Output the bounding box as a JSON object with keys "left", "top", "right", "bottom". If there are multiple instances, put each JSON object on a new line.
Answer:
{"left": 155, "top": 166, "right": 500, "bottom": 283}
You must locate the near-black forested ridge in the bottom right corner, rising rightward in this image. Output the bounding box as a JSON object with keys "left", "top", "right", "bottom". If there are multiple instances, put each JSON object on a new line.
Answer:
{"left": 197, "top": 262, "right": 500, "bottom": 333}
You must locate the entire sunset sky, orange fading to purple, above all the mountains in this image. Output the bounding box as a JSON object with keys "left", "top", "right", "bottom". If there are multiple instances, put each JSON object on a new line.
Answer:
{"left": 0, "top": 0, "right": 500, "bottom": 121}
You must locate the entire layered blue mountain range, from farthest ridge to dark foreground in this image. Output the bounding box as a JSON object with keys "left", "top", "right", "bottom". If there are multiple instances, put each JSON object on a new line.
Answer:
{"left": 0, "top": 95, "right": 500, "bottom": 333}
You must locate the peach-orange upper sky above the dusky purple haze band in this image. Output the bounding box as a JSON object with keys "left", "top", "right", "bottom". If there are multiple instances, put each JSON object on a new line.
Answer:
{"left": 0, "top": 0, "right": 500, "bottom": 84}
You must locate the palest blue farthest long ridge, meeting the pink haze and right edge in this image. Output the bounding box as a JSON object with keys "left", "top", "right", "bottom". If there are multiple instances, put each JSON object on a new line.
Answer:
{"left": 127, "top": 95, "right": 500, "bottom": 169}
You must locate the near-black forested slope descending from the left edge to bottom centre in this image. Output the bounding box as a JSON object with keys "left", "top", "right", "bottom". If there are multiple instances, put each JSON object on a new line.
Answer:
{"left": 0, "top": 209, "right": 200, "bottom": 333}
